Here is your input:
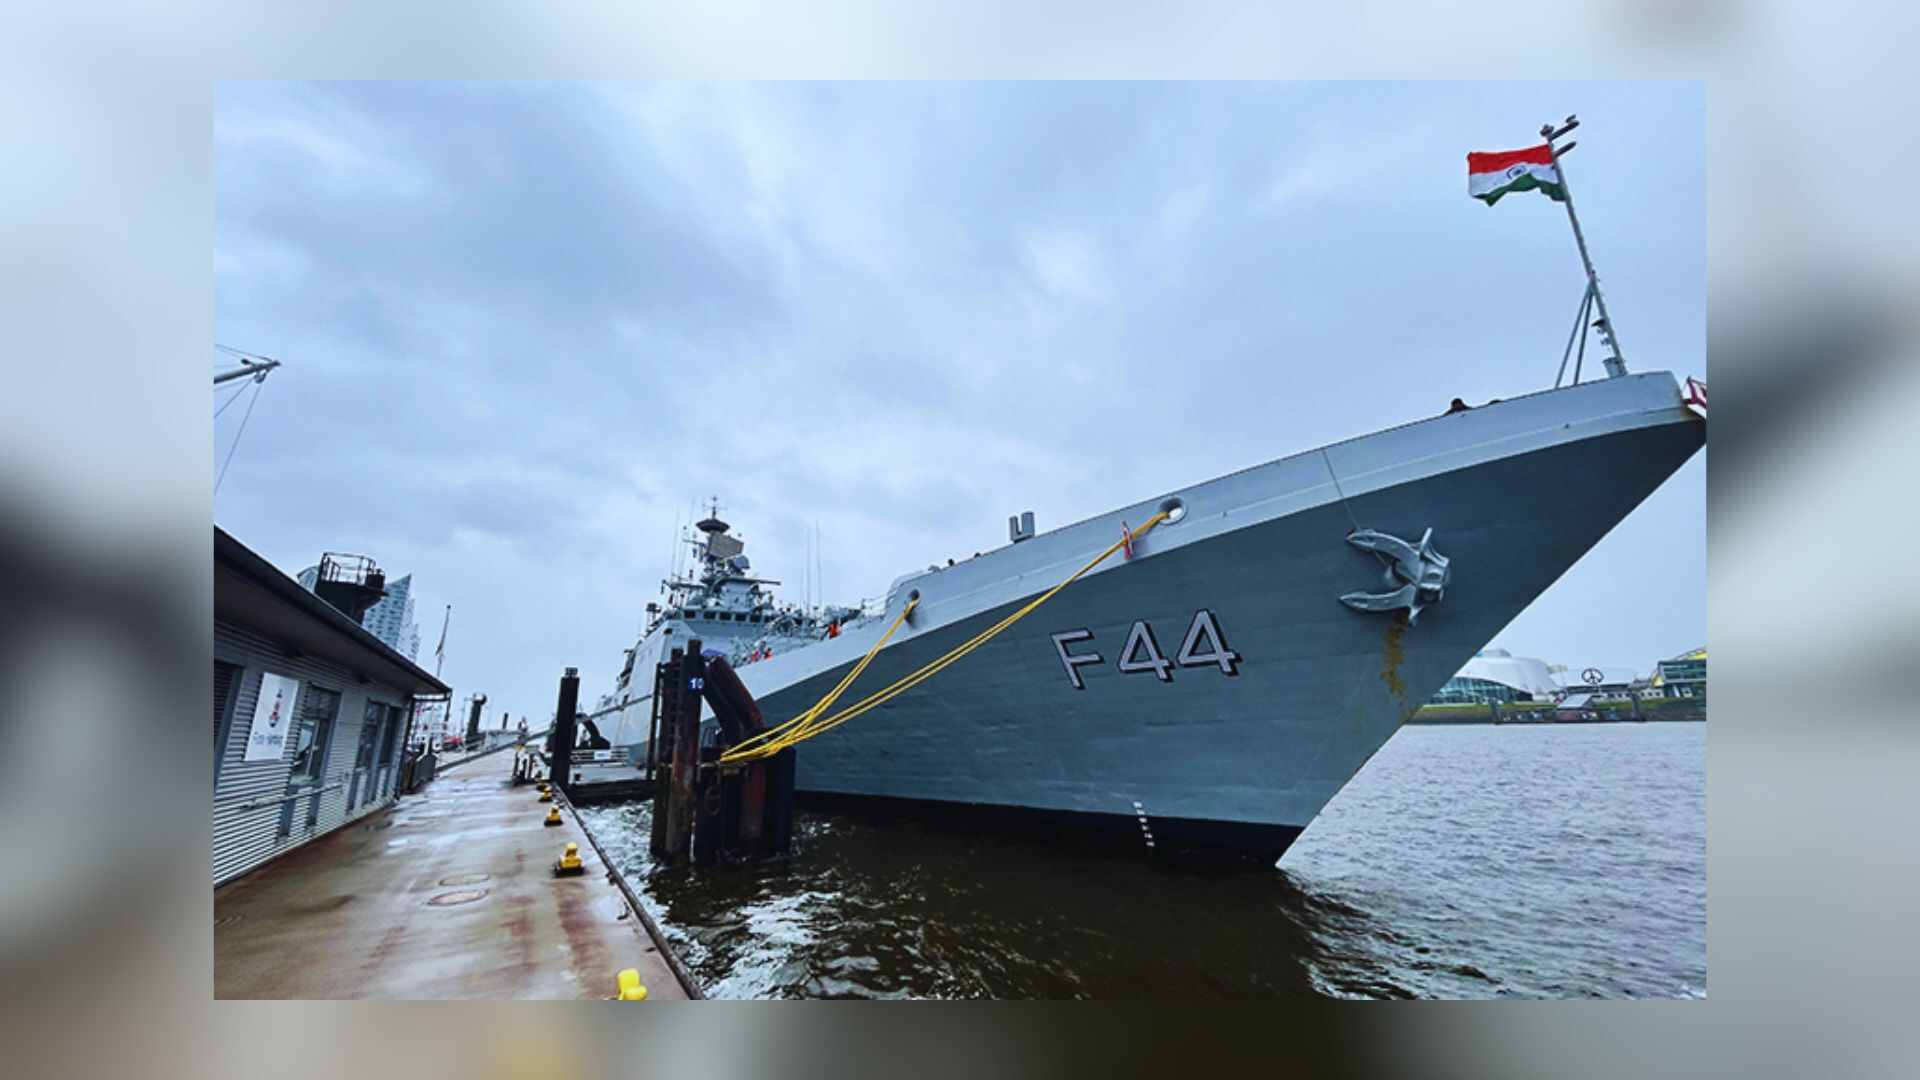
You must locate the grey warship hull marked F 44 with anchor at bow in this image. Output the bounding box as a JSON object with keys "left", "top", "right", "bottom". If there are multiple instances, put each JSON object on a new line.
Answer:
{"left": 622, "top": 373, "right": 1705, "bottom": 859}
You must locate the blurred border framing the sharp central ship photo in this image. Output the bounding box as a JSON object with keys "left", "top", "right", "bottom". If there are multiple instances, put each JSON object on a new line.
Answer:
{"left": 0, "top": 2, "right": 1920, "bottom": 1076}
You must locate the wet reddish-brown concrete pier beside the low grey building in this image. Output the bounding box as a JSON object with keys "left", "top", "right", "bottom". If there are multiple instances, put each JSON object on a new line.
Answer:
{"left": 213, "top": 753, "right": 687, "bottom": 1001}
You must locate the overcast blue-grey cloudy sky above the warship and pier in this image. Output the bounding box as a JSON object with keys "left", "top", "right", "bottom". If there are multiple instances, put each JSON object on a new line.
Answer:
{"left": 213, "top": 83, "right": 1707, "bottom": 717}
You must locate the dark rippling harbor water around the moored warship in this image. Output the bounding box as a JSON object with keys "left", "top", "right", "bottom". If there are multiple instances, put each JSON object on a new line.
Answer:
{"left": 580, "top": 723, "right": 1707, "bottom": 997}
